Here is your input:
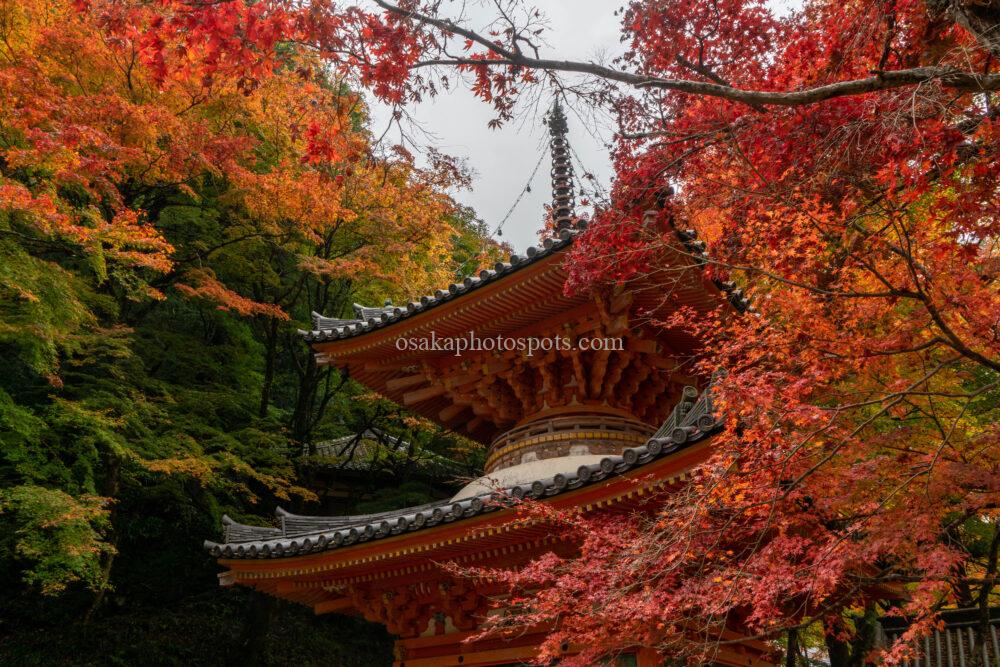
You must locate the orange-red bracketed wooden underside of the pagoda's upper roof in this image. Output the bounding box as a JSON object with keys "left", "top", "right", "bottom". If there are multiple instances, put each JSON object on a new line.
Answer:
{"left": 313, "top": 243, "right": 720, "bottom": 444}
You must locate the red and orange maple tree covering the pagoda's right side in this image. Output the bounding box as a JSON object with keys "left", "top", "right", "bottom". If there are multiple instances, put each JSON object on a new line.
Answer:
{"left": 352, "top": 0, "right": 1000, "bottom": 665}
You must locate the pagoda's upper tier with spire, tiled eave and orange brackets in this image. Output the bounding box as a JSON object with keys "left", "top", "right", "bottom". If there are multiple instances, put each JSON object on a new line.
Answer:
{"left": 301, "top": 98, "right": 747, "bottom": 454}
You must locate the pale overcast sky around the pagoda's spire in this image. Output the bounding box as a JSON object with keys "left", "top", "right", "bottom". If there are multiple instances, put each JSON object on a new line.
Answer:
{"left": 371, "top": 0, "right": 622, "bottom": 251}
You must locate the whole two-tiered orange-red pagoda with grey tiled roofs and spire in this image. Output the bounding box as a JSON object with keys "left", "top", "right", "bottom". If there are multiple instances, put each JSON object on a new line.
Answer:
{"left": 206, "top": 103, "right": 773, "bottom": 667}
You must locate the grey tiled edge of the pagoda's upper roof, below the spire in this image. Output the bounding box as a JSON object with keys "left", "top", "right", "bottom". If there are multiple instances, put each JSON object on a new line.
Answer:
{"left": 300, "top": 227, "right": 586, "bottom": 343}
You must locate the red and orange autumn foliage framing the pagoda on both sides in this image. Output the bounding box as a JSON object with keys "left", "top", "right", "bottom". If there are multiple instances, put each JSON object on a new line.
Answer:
{"left": 0, "top": 0, "right": 1000, "bottom": 665}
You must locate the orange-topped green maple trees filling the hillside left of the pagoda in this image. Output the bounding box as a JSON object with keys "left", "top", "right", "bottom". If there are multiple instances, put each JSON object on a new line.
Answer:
{"left": 0, "top": 0, "right": 498, "bottom": 662}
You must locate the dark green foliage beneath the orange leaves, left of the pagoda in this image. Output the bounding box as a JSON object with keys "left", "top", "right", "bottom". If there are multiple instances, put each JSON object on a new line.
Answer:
{"left": 0, "top": 95, "right": 496, "bottom": 665}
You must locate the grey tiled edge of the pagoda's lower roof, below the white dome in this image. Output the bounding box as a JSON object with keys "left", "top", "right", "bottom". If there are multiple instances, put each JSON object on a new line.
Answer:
{"left": 205, "top": 380, "right": 719, "bottom": 559}
